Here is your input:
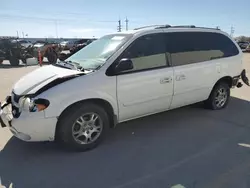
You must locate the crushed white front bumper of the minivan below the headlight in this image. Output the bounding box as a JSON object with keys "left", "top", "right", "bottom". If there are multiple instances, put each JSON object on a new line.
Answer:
{"left": 0, "top": 97, "right": 57, "bottom": 142}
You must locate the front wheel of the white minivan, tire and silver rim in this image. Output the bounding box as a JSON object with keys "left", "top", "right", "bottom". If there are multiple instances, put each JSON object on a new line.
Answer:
{"left": 56, "top": 103, "right": 109, "bottom": 152}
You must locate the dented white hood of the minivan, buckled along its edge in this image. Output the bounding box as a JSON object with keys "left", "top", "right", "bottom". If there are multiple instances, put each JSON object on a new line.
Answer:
{"left": 13, "top": 65, "right": 84, "bottom": 95}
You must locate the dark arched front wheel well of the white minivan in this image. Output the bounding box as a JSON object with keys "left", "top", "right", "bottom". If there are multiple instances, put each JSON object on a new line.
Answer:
{"left": 55, "top": 98, "right": 117, "bottom": 140}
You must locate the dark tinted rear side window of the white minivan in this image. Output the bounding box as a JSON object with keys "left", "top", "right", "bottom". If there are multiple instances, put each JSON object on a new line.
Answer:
{"left": 166, "top": 32, "right": 239, "bottom": 66}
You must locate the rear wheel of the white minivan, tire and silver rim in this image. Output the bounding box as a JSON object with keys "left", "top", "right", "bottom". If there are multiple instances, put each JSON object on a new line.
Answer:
{"left": 205, "top": 82, "right": 230, "bottom": 110}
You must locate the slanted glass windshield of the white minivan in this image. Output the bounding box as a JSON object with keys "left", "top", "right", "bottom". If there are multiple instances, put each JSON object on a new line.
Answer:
{"left": 67, "top": 34, "right": 131, "bottom": 69}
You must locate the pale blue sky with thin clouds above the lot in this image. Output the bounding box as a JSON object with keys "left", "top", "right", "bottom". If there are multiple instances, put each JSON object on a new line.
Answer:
{"left": 0, "top": 0, "right": 250, "bottom": 38}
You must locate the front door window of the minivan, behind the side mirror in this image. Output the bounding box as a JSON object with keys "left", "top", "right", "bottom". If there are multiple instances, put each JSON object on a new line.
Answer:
{"left": 119, "top": 33, "right": 166, "bottom": 72}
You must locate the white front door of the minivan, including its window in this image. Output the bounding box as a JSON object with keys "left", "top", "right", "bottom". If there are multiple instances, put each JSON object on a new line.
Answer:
{"left": 117, "top": 33, "right": 173, "bottom": 122}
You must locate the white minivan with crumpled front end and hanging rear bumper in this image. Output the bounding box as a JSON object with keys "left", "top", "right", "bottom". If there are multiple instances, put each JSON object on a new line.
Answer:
{"left": 0, "top": 25, "right": 249, "bottom": 151}
